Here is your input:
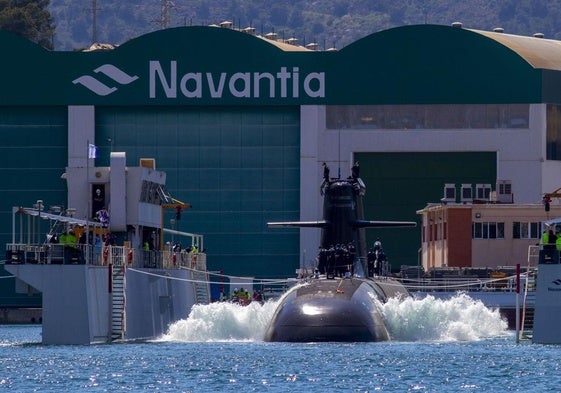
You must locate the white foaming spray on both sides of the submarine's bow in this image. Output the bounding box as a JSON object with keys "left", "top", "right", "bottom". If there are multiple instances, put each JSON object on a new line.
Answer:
{"left": 162, "top": 294, "right": 508, "bottom": 342}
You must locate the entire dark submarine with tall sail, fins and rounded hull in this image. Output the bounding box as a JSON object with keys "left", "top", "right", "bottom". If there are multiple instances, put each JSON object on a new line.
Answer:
{"left": 264, "top": 163, "right": 416, "bottom": 342}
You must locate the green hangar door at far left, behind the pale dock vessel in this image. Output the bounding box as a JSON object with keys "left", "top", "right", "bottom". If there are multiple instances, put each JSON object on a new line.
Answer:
{"left": 0, "top": 107, "right": 68, "bottom": 307}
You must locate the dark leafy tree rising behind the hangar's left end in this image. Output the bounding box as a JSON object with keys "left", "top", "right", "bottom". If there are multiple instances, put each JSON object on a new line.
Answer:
{"left": 0, "top": 0, "right": 55, "bottom": 49}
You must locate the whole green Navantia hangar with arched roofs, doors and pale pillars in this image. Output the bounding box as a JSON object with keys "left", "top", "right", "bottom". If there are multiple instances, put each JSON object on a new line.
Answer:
{"left": 0, "top": 24, "right": 561, "bottom": 284}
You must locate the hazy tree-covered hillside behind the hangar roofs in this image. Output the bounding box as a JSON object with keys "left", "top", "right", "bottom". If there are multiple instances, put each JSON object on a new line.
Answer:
{"left": 5, "top": 0, "right": 561, "bottom": 50}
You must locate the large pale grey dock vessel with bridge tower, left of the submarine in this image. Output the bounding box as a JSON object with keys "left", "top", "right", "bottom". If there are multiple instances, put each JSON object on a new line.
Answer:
{"left": 5, "top": 153, "right": 210, "bottom": 344}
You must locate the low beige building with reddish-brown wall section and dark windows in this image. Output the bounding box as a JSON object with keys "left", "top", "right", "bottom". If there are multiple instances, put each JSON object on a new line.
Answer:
{"left": 417, "top": 196, "right": 561, "bottom": 271}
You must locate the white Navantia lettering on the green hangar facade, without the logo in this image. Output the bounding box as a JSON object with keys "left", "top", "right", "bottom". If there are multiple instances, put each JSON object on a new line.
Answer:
{"left": 149, "top": 60, "right": 325, "bottom": 98}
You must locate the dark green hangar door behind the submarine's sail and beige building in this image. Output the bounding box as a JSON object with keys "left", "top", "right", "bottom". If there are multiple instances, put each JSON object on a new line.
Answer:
{"left": 354, "top": 152, "right": 497, "bottom": 270}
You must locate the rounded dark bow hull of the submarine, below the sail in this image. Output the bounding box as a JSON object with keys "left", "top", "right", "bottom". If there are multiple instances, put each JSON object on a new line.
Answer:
{"left": 264, "top": 278, "right": 407, "bottom": 342}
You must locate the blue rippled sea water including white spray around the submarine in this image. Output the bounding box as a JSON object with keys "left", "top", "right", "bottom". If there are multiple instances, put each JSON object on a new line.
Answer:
{"left": 0, "top": 295, "right": 561, "bottom": 393}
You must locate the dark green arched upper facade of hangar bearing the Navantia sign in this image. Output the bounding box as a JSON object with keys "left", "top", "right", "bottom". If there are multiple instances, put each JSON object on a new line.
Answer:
{"left": 0, "top": 25, "right": 548, "bottom": 105}
